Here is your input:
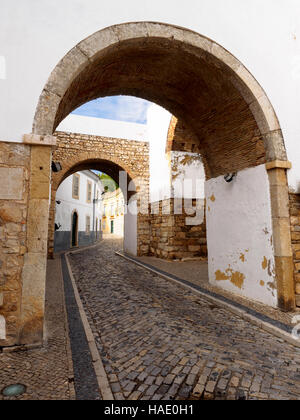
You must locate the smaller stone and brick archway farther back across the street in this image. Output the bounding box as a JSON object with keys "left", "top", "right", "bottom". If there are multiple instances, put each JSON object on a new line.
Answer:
{"left": 48, "top": 132, "right": 149, "bottom": 257}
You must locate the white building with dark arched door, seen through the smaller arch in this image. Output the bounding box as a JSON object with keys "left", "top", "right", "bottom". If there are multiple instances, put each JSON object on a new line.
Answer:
{"left": 54, "top": 171, "right": 103, "bottom": 252}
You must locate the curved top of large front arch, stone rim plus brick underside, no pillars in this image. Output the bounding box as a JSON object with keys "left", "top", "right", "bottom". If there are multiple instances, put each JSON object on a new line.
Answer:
{"left": 34, "top": 24, "right": 286, "bottom": 178}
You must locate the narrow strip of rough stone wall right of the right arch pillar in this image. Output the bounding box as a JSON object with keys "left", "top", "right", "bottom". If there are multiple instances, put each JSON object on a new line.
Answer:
{"left": 289, "top": 193, "right": 300, "bottom": 307}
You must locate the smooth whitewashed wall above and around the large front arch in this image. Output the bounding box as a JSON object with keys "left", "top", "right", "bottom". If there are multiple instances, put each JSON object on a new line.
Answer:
{"left": 0, "top": 0, "right": 300, "bottom": 191}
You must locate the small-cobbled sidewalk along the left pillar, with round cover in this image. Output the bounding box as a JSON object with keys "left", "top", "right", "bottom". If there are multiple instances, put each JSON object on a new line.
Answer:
{"left": 0, "top": 261, "right": 75, "bottom": 400}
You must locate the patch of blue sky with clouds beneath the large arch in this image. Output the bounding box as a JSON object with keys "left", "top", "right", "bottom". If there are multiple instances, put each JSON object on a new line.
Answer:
{"left": 72, "top": 96, "right": 151, "bottom": 124}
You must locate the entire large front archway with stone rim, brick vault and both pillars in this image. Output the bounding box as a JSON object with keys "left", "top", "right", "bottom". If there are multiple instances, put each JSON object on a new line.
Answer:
{"left": 15, "top": 22, "right": 295, "bottom": 343}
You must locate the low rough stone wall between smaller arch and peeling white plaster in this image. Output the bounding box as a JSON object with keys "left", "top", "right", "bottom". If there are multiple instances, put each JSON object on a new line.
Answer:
{"left": 149, "top": 198, "right": 207, "bottom": 260}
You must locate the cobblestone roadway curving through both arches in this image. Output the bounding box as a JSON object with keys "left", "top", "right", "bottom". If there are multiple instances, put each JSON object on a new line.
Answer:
{"left": 70, "top": 240, "right": 300, "bottom": 400}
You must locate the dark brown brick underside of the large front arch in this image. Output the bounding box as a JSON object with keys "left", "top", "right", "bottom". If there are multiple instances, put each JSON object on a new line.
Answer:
{"left": 55, "top": 39, "right": 264, "bottom": 178}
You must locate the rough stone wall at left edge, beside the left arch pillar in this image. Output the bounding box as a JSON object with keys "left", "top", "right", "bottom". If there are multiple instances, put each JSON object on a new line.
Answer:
{"left": 0, "top": 142, "right": 30, "bottom": 347}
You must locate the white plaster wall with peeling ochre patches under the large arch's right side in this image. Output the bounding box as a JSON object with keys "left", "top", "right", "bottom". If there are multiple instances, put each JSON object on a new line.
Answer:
{"left": 205, "top": 165, "right": 277, "bottom": 307}
